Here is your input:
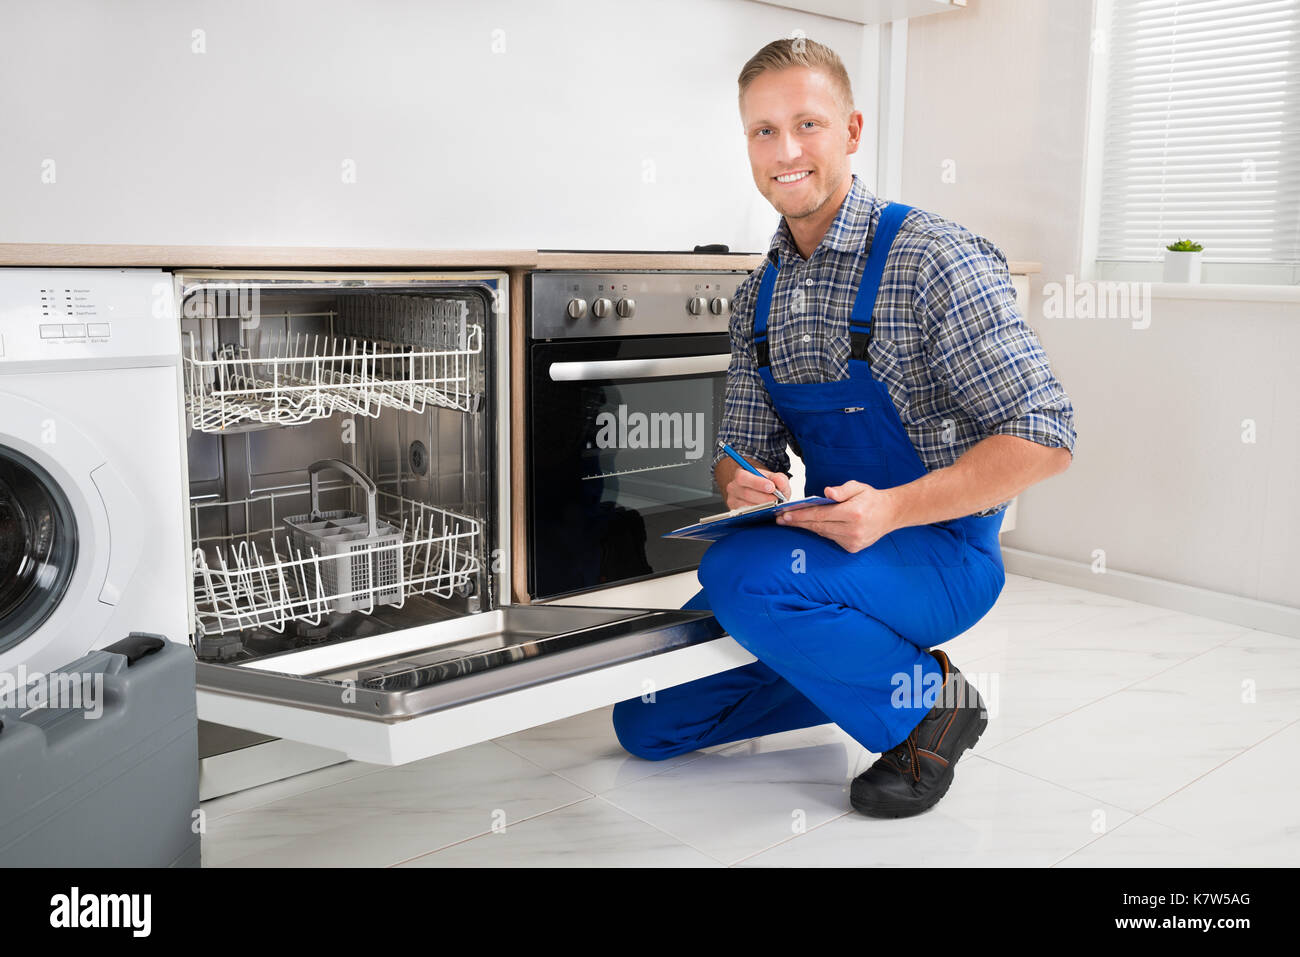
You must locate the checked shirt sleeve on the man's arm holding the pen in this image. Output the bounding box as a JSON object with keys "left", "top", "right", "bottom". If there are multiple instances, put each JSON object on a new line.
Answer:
{"left": 712, "top": 263, "right": 790, "bottom": 473}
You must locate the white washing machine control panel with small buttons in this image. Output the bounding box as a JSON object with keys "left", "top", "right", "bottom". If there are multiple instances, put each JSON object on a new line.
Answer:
{"left": 0, "top": 269, "right": 181, "bottom": 372}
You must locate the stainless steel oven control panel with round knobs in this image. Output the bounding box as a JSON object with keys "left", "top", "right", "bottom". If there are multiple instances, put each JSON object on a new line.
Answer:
{"left": 528, "top": 270, "right": 749, "bottom": 339}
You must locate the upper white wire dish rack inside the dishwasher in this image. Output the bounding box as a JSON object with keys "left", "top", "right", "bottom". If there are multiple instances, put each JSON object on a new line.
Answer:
{"left": 185, "top": 295, "right": 482, "bottom": 432}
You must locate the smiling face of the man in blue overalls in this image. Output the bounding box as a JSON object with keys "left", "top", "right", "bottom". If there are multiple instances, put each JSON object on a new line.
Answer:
{"left": 741, "top": 66, "right": 862, "bottom": 220}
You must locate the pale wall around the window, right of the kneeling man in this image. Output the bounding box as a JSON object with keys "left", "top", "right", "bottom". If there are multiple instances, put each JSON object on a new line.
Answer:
{"left": 901, "top": 0, "right": 1300, "bottom": 606}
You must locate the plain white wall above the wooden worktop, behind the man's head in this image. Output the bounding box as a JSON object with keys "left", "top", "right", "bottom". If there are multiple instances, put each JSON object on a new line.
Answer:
{"left": 0, "top": 0, "right": 876, "bottom": 251}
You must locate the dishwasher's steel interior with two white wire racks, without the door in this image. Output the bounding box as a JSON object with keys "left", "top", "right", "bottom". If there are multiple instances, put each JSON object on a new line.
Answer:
{"left": 181, "top": 276, "right": 501, "bottom": 664}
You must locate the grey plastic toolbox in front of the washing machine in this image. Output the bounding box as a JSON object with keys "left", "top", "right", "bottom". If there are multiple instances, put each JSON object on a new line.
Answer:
{"left": 0, "top": 633, "right": 200, "bottom": 867}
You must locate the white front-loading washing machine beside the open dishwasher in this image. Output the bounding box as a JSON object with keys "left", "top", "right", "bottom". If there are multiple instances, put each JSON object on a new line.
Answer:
{"left": 0, "top": 269, "right": 190, "bottom": 683}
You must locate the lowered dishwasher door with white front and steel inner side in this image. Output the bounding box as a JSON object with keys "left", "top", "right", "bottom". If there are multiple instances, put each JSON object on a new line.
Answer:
{"left": 198, "top": 605, "right": 738, "bottom": 765}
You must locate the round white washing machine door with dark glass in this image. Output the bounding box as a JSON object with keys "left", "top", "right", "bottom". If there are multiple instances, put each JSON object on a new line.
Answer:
{"left": 0, "top": 391, "right": 142, "bottom": 675}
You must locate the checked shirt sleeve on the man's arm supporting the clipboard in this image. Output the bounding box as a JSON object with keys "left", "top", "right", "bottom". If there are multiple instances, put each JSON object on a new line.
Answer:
{"left": 914, "top": 234, "right": 1075, "bottom": 458}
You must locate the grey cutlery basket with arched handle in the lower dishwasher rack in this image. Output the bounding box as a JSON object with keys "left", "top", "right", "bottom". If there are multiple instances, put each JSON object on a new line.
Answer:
{"left": 283, "top": 459, "right": 402, "bottom": 612}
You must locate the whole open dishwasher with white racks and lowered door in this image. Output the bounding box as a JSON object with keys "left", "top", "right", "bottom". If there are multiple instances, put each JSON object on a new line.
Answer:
{"left": 174, "top": 269, "right": 735, "bottom": 765}
